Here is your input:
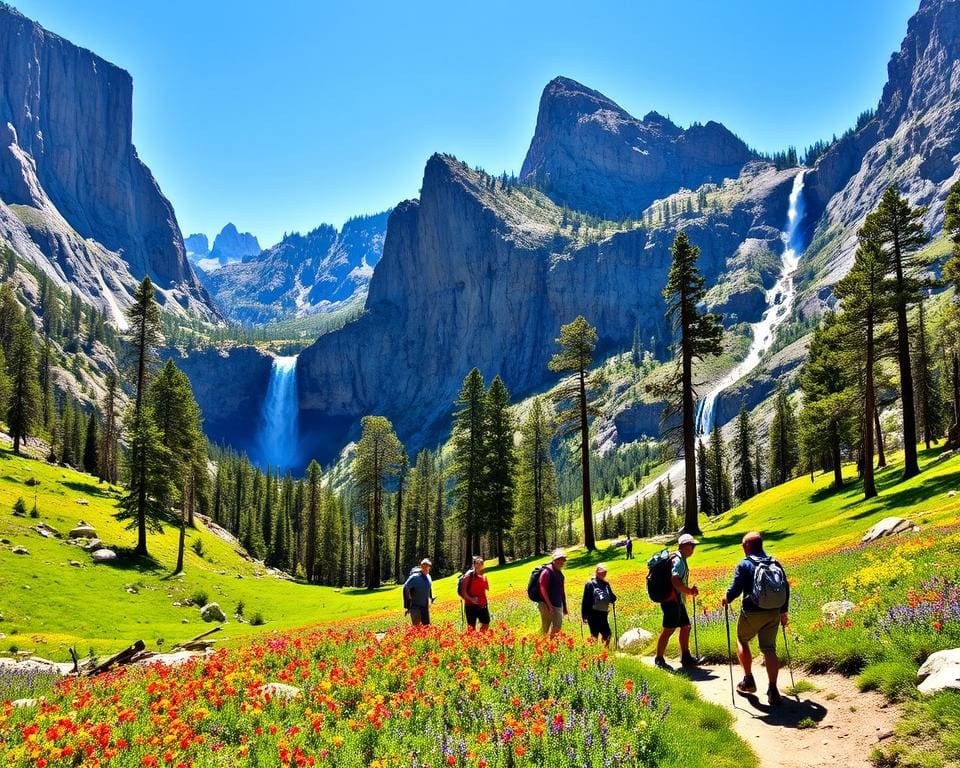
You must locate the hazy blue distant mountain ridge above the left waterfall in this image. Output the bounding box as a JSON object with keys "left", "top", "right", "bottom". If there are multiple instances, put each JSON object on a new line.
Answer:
{"left": 205, "top": 211, "right": 389, "bottom": 323}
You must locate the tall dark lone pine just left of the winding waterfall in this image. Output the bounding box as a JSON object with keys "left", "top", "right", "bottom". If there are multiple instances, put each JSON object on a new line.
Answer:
{"left": 663, "top": 232, "right": 723, "bottom": 534}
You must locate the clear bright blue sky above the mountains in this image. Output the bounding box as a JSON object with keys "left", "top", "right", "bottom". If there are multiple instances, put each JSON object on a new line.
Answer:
{"left": 12, "top": 0, "right": 918, "bottom": 246}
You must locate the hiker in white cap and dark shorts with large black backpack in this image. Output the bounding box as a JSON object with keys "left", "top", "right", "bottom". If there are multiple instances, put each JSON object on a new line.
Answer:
{"left": 647, "top": 533, "right": 701, "bottom": 669}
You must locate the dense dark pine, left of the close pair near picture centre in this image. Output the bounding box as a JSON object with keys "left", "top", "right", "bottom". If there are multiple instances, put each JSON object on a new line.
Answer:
{"left": 453, "top": 368, "right": 486, "bottom": 570}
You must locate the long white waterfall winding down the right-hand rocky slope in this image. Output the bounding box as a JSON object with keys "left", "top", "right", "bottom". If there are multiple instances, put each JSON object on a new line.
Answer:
{"left": 696, "top": 171, "right": 804, "bottom": 439}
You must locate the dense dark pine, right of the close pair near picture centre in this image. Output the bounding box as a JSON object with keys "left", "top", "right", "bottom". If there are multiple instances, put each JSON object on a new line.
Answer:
{"left": 483, "top": 376, "right": 517, "bottom": 565}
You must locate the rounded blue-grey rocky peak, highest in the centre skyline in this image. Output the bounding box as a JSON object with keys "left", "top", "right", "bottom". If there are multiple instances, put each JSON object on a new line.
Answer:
{"left": 520, "top": 78, "right": 755, "bottom": 220}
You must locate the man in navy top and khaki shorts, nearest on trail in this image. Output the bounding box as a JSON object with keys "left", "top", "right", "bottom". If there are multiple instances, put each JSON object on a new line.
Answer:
{"left": 721, "top": 531, "right": 790, "bottom": 705}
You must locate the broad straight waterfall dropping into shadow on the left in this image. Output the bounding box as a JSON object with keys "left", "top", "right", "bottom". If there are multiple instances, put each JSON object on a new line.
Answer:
{"left": 257, "top": 355, "right": 300, "bottom": 471}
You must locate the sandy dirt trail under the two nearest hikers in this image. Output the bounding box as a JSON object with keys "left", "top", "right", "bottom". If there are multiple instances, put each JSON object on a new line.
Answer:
{"left": 645, "top": 658, "right": 900, "bottom": 768}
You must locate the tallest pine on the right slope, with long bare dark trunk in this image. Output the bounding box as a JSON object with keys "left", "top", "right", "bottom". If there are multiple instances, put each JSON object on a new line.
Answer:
{"left": 863, "top": 185, "right": 930, "bottom": 480}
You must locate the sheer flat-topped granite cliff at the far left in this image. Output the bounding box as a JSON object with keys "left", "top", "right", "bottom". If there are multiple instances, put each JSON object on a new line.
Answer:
{"left": 0, "top": 5, "right": 218, "bottom": 318}
